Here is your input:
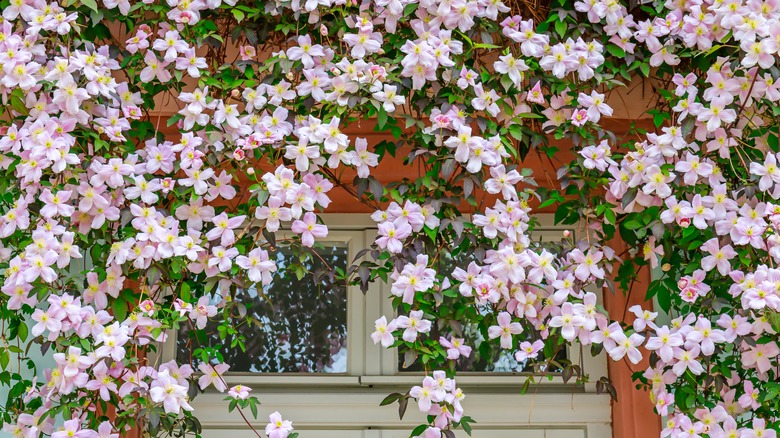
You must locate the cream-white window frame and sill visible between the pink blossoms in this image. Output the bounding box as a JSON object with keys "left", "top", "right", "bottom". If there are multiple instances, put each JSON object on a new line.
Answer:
{"left": 155, "top": 213, "right": 611, "bottom": 438}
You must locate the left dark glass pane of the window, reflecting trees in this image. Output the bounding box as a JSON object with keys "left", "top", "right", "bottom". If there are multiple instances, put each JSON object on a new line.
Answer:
{"left": 177, "top": 242, "right": 348, "bottom": 373}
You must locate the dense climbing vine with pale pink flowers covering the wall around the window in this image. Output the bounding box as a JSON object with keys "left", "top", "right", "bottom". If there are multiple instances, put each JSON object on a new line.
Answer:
{"left": 0, "top": 0, "right": 780, "bottom": 438}
